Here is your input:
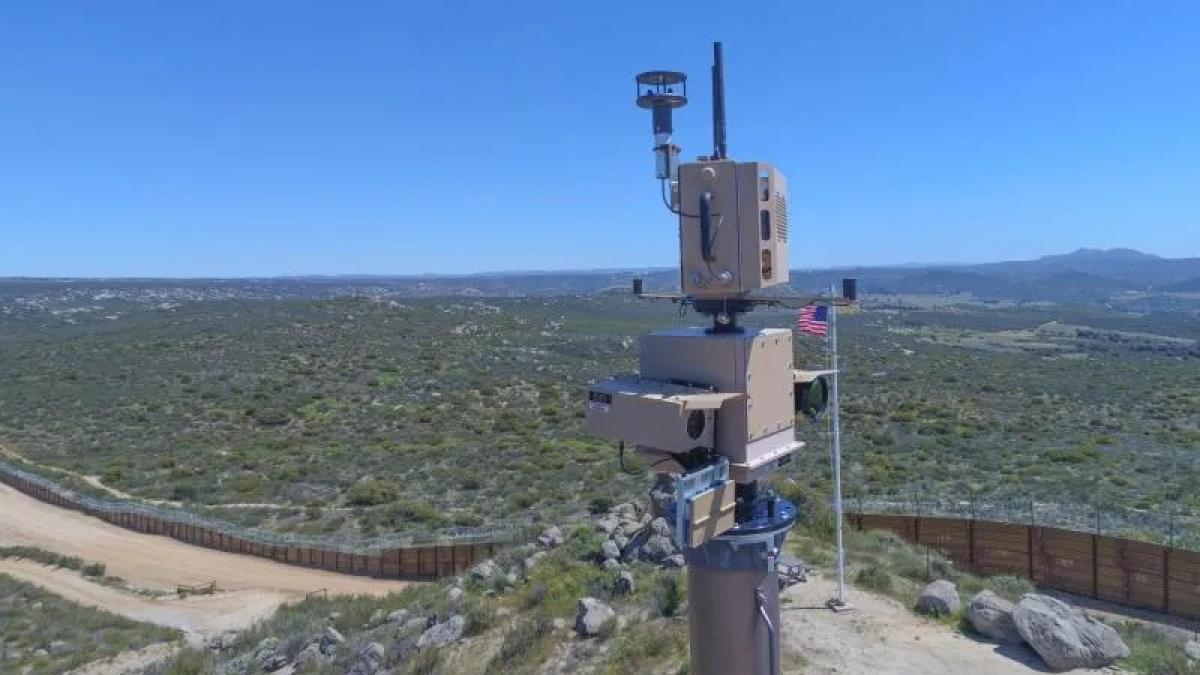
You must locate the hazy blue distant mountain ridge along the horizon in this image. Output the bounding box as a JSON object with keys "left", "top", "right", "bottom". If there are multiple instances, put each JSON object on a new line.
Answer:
{"left": 0, "top": 249, "right": 1200, "bottom": 309}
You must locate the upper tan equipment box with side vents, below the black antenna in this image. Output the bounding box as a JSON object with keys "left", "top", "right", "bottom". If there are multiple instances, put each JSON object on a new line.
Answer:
{"left": 679, "top": 160, "right": 788, "bottom": 299}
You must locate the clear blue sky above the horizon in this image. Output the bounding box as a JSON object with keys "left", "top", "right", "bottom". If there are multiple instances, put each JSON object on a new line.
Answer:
{"left": 0, "top": 0, "right": 1200, "bottom": 276}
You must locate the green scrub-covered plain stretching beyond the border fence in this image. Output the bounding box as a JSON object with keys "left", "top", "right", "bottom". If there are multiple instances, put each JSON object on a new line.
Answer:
{"left": 0, "top": 293, "right": 1200, "bottom": 540}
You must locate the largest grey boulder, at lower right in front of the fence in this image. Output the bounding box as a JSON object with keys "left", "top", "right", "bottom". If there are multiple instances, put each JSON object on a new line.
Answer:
{"left": 1013, "top": 593, "right": 1129, "bottom": 671}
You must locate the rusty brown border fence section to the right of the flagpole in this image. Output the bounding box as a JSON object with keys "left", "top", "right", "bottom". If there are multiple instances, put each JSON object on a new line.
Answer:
{"left": 846, "top": 501, "right": 1200, "bottom": 620}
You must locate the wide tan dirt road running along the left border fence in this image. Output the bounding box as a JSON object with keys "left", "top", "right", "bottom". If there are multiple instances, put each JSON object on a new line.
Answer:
{"left": 0, "top": 484, "right": 406, "bottom": 599}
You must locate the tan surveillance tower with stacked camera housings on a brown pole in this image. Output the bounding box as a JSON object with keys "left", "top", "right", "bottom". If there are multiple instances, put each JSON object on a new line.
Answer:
{"left": 587, "top": 42, "right": 829, "bottom": 675}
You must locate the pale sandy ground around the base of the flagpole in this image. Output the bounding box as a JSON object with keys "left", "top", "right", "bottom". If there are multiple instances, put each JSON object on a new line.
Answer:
{"left": 781, "top": 574, "right": 1105, "bottom": 675}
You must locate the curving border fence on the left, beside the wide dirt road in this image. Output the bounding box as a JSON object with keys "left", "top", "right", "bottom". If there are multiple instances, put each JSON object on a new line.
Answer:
{"left": 0, "top": 461, "right": 523, "bottom": 579}
